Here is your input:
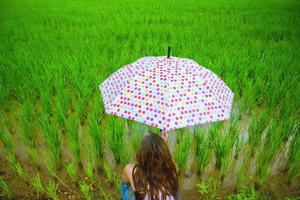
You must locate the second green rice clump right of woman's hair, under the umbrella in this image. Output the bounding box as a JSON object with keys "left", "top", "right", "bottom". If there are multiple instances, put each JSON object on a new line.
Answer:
{"left": 195, "top": 127, "right": 212, "bottom": 174}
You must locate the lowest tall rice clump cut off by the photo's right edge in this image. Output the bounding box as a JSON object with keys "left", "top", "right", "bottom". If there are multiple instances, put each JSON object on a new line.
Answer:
{"left": 287, "top": 132, "right": 300, "bottom": 183}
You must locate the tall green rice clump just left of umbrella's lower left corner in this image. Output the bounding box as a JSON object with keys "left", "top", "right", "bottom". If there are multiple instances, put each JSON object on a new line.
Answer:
{"left": 88, "top": 108, "right": 105, "bottom": 163}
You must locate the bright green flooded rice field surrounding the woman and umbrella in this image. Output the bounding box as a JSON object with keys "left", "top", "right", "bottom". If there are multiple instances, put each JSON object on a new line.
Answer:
{"left": 0, "top": 0, "right": 300, "bottom": 199}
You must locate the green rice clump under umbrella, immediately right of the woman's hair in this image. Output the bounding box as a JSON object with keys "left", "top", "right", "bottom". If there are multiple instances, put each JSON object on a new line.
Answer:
{"left": 174, "top": 129, "right": 192, "bottom": 174}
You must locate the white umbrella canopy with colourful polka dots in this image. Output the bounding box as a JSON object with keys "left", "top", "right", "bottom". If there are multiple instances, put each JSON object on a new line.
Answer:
{"left": 100, "top": 56, "right": 234, "bottom": 131}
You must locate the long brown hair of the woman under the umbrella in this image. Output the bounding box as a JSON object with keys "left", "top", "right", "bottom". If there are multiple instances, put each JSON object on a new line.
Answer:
{"left": 133, "top": 133, "right": 178, "bottom": 200}
